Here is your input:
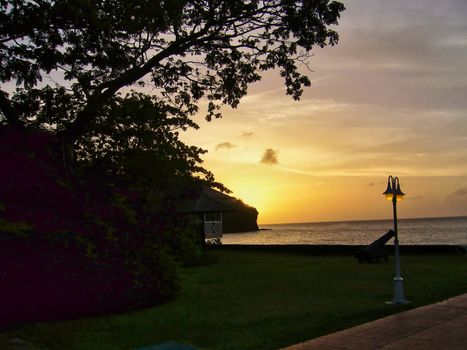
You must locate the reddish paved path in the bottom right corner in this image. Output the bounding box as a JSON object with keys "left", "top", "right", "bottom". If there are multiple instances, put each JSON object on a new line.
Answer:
{"left": 283, "top": 294, "right": 467, "bottom": 350}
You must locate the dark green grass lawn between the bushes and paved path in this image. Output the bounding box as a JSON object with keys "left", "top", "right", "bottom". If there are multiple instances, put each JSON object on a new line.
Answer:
{"left": 0, "top": 250, "right": 467, "bottom": 350}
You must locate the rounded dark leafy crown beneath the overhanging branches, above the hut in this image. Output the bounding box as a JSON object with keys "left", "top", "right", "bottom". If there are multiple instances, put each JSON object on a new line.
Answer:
{"left": 76, "top": 92, "right": 220, "bottom": 191}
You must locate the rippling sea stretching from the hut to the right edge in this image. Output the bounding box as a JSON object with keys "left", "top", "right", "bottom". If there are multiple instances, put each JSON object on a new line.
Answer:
{"left": 222, "top": 216, "right": 467, "bottom": 246}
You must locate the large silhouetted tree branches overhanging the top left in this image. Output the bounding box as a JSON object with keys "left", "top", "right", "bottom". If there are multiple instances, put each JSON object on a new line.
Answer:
{"left": 0, "top": 0, "right": 344, "bottom": 149}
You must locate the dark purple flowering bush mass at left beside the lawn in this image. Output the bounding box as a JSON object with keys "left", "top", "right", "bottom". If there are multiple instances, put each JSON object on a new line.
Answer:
{"left": 0, "top": 127, "right": 181, "bottom": 328}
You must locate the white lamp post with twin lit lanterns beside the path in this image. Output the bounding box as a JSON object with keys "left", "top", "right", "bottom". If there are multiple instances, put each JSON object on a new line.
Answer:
{"left": 383, "top": 175, "right": 408, "bottom": 304}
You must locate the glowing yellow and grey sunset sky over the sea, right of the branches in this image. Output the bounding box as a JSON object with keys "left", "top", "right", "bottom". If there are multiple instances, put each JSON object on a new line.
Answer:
{"left": 183, "top": 0, "right": 467, "bottom": 224}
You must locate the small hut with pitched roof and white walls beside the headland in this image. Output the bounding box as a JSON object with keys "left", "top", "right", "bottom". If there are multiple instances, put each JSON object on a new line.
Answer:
{"left": 182, "top": 186, "right": 235, "bottom": 239}
